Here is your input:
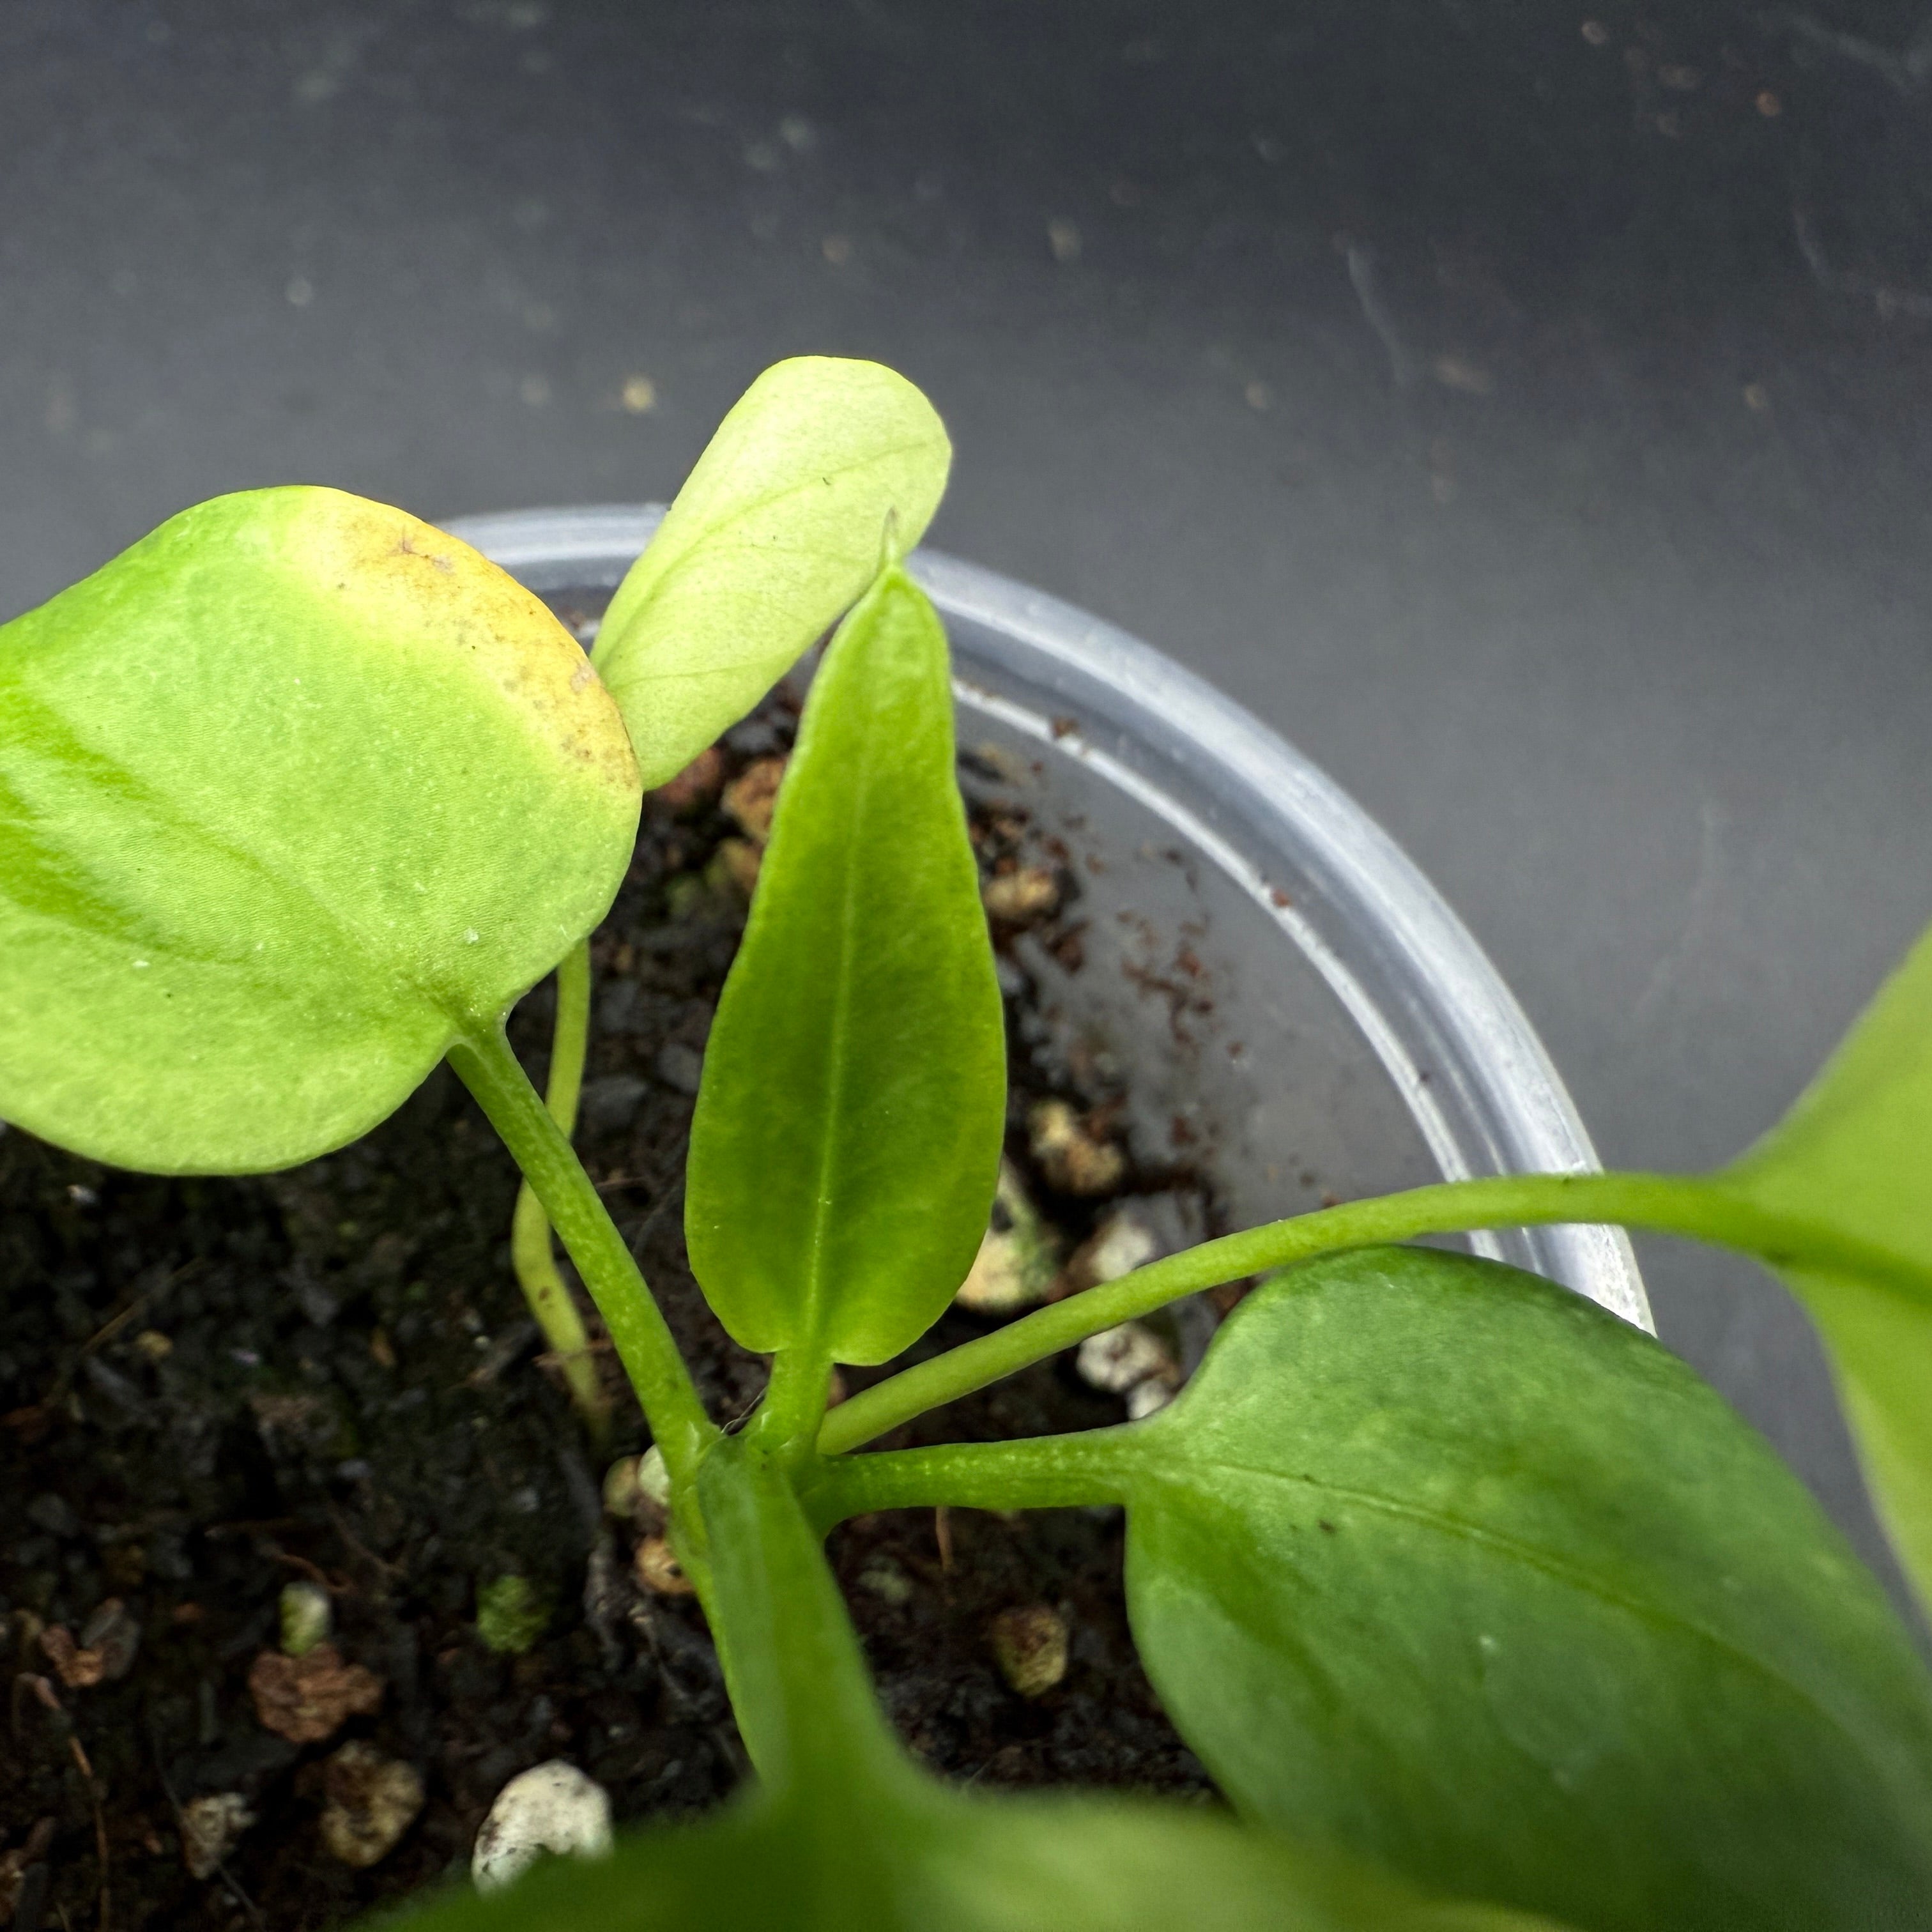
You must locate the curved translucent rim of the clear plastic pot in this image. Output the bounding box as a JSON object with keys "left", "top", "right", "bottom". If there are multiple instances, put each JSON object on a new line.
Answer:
{"left": 442, "top": 504, "right": 1656, "bottom": 1333}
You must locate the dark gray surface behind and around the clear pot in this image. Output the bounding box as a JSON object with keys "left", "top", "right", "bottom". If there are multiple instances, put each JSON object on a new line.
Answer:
{"left": 0, "top": 0, "right": 1932, "bottom": 1549}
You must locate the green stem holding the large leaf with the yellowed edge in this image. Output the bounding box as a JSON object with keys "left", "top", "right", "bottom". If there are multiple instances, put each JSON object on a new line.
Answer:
{"left": 450, "top": 1026, "right": 719, "bottom": 1482}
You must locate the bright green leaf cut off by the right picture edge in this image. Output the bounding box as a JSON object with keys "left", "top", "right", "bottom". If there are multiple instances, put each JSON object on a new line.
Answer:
{"left": 1708, "top": 933, "right": 1932, "bottom": 1606}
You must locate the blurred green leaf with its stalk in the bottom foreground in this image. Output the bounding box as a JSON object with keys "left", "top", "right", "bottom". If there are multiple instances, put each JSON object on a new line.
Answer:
{"left": 380, "top": 1438, "right": 1547, "bottom": 1932}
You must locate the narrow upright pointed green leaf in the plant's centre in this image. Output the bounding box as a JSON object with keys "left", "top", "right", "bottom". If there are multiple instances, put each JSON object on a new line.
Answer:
{"left": 684, "top": 564, "right": 1004, "bottom": 1362}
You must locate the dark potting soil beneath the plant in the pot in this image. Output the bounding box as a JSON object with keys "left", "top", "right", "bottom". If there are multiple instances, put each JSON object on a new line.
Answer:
{"left": 0, "top": 649, "right": 1209, "bottom": 1932}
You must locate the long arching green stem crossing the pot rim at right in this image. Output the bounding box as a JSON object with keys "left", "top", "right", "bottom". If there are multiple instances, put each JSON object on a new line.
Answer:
{"left": 819, "top": 1175, "right": 1913, "bottom": 1455}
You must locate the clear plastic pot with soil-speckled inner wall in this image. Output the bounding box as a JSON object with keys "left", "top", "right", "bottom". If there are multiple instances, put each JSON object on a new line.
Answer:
{"left": 448, "top": 504, "right": 1652, "bottom": 1330}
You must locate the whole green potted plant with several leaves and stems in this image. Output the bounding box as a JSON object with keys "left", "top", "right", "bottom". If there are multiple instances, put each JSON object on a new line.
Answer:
{"left": 0, "top": 364, "right": 1932, "bottom": 1932}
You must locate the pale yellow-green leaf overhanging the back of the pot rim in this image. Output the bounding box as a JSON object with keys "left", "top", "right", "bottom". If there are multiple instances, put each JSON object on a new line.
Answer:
{"left": 595, "top": 355, "right": 953, "bottom": 786}
